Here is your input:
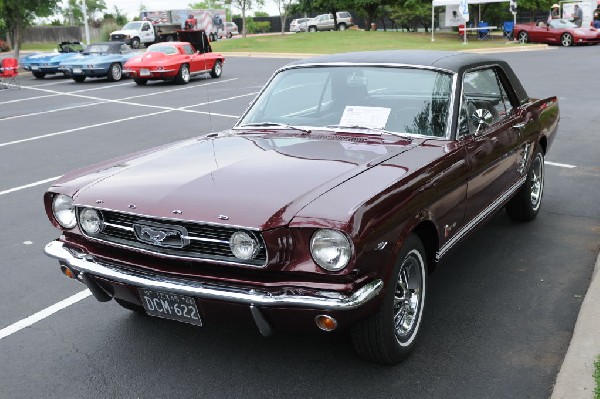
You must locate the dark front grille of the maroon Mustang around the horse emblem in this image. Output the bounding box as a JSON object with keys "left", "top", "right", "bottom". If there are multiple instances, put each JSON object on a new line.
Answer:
{"left": 77, "top": 208, "right": 267, "bottom": 266}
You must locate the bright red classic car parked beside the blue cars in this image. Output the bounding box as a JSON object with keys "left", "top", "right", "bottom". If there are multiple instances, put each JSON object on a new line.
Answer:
{"left": 123, "top": 31, "right": 225, "bottom": 85}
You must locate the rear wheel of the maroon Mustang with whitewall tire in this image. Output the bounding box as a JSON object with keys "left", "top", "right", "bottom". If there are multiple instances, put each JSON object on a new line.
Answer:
{"left": 506, "top": 147, "right": 544, "bottom": 222}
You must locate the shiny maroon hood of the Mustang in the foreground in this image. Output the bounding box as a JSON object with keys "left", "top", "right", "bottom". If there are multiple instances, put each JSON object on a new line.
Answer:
{"left": 55, "top": 134, "right": 422, "bottom": 229}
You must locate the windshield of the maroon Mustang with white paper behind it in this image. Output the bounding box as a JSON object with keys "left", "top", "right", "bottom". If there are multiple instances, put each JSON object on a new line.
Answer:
{"left": 236, "top": 66, "right": 452, "bottom": 137}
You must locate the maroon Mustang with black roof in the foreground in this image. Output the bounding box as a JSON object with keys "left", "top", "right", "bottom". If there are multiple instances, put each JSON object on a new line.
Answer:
{"left": 44, "top": 51, "right": 559, "bottom": 364}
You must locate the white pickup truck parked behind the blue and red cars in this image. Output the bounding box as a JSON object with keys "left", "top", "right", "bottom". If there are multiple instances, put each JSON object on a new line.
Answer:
{"left": 110, "top": 21, "right": 181, "bottom": 49}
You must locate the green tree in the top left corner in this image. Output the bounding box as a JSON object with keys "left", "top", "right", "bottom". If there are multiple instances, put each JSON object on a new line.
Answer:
{"left": 0, "top": 0, "right": 58, "bottom": 58}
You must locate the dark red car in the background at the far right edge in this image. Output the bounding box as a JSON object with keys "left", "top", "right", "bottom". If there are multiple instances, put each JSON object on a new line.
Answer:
{"left": 513, "top": 19, "right": 600, "bottom": 47}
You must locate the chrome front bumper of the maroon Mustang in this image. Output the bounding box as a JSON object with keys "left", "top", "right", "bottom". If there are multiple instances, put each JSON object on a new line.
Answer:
{"left": 44, "top": 241, "right": 383, "bottom": 310}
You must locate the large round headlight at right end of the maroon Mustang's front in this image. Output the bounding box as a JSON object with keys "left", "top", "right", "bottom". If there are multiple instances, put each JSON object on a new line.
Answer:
{"left": 310, "top": 229, "right": 352, "bottom": 272}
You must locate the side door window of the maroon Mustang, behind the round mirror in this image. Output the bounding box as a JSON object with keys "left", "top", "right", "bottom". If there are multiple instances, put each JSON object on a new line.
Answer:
{"left": 459, "top": 68, "right": 512, "bottom": 135}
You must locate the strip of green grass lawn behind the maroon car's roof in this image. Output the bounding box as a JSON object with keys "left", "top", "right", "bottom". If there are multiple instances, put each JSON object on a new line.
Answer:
{"left": 212, "top": 29, "right": 521, "bottom": 54}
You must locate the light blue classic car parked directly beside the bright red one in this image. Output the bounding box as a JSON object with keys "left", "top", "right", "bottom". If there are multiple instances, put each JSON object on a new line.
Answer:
{"left": 59, "top": 42, "right": 135, "bottom": 83}
